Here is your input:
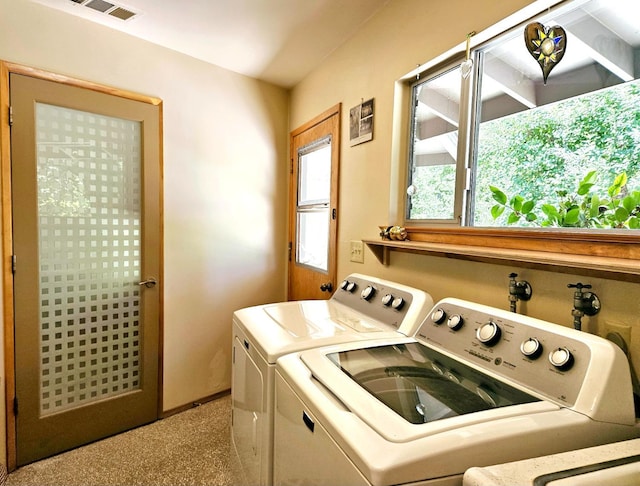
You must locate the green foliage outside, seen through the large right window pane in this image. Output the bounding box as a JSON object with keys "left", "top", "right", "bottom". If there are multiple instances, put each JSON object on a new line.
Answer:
{"left": 473, "top": 82, "right": 640, "bottom": 229}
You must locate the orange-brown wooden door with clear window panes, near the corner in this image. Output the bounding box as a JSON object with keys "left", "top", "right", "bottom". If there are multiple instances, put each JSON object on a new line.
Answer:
{"left": 288, "top": 105, "right": 341, "bottom": 300}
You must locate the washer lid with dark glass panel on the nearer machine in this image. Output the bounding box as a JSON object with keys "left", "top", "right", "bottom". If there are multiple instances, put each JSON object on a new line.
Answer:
{"left": 300, "top": 339, "right": 558, "bottom": 442}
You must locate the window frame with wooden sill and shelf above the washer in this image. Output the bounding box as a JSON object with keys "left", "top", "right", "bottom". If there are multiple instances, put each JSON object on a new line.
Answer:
{"left": 384, "top": 0, "right": 640, "bottom": 282}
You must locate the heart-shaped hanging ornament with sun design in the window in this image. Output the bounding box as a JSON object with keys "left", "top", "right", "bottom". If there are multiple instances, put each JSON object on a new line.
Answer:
{"left": 524, "top": 22, "right": 567, "bottom": 84}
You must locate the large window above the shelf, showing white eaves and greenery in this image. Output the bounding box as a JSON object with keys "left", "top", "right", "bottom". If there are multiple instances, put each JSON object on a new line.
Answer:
{"left": 405, "top": 0, "right": 640, "bottom": 230}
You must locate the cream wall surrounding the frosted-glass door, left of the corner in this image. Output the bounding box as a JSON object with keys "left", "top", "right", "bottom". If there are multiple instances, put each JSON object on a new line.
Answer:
{"left": 0, "top": 0, "right": 289, "bottom": 428}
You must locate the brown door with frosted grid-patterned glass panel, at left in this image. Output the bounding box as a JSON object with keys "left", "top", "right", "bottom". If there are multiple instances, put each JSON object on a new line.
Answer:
{"left": 10, "top": 74, "right": 162, "bottom": 465}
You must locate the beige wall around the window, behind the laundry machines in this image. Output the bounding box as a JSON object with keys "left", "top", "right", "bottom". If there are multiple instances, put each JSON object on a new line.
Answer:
{"left": 291, "top": 0, "right": 640, "bottom": 369}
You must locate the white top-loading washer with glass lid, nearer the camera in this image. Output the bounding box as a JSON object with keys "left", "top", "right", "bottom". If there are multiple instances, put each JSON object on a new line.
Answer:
{"left": 274, "top": 299, "right": 640, "bottom": 486}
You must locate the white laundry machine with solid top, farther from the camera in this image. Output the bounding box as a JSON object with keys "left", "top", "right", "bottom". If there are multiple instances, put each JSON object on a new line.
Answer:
{"left": 231, "top": 274, "right": 433, "bottom": 485}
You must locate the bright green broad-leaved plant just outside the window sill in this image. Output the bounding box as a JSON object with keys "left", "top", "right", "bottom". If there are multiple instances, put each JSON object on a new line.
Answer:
{"left": 489, "top": 170, "right": 640, "bottom": 229}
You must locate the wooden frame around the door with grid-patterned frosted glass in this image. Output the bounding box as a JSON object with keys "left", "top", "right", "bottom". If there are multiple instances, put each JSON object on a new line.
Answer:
{"left": 0, "top": 60, "right": 164, "bottom": 471}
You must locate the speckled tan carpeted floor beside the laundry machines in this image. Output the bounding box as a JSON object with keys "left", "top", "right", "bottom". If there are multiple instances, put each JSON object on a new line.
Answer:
{"left": 6, "top": 395, "right": 237, "bottom": 486}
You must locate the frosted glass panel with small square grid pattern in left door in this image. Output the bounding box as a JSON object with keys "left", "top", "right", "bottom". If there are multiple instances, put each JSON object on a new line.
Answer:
{"left": 36, "top": 103, "right": 141, "bottom": 416}
